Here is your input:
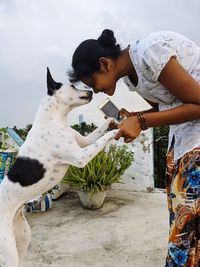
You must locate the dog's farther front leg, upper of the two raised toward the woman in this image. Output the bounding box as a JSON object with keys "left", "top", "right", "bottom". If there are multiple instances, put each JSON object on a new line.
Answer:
{"left": 75, "top": 118, "right": 114, "bottom": 147}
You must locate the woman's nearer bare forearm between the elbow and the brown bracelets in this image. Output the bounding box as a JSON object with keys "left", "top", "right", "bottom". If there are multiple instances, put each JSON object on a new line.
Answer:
{"left": 144, "top": 104, "right": 200, "bottom": 127}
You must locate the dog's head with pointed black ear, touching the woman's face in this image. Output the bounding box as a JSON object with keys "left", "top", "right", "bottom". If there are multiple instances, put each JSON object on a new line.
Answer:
{"left": 47, "top": 68, "right": 92, "bottom": 108}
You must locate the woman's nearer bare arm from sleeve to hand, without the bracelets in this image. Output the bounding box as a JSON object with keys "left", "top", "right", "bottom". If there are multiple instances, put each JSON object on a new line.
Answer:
{"left": 115, "top": 57, "right": 200, "bottom": 142}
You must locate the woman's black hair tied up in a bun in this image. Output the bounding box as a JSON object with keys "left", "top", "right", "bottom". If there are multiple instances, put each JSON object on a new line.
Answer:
{"left": 68, "top": 29, "right": 121, "bottom": 83}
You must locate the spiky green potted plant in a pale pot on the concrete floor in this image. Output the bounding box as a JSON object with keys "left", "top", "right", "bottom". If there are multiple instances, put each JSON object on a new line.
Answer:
{"left": 63, "top": 144, "right": 134, "bottom": 209}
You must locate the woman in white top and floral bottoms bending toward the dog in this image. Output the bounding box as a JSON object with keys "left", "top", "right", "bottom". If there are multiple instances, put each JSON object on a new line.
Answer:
{"left": 69, "top": 30, "right": 200, "bottom": 267}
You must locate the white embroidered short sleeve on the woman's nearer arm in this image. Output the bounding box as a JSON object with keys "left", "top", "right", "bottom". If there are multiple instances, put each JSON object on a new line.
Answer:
{"left": 141, "top": 40, "right": 177, "bottom": 81}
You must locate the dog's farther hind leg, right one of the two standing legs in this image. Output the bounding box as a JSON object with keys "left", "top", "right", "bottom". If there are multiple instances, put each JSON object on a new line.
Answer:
{"left": 13, "top": 207, "right": 31, "bottom": 266}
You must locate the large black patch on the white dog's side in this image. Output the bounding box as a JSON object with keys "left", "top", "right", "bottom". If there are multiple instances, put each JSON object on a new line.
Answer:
{"left": 7, "top": 157, "right": 46, "bottom": 186}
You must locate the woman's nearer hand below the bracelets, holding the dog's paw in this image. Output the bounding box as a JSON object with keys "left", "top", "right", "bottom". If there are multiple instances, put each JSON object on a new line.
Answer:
{"left": 115, "top": 116, "right": 142, "bottom": 143}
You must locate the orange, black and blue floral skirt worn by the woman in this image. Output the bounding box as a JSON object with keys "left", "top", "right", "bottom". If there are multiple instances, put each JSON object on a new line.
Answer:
{"left": 165, "top": 147, "right": 200, "bottom": 267}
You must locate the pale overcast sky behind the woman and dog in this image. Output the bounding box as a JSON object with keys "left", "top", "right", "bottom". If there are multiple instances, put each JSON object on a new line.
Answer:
{"left": 0, "top": 0, "right": 200, "bottom": 128}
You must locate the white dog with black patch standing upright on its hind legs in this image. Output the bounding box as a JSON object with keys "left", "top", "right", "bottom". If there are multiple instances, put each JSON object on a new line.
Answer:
{"left": 0, "top": 68, "right": 116, "bottom": 267}
